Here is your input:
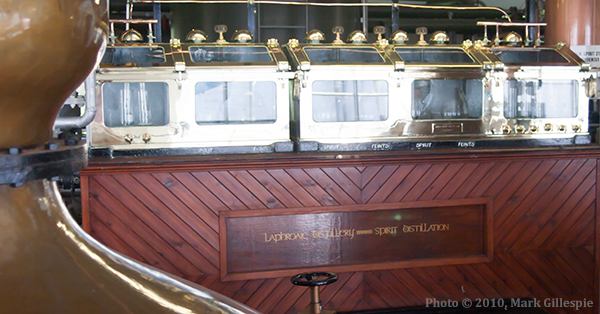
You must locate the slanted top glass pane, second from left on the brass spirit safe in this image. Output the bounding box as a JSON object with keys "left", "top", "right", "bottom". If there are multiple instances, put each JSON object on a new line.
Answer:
{"left": 189, "top": 46, "right": 273, "bottom": 63}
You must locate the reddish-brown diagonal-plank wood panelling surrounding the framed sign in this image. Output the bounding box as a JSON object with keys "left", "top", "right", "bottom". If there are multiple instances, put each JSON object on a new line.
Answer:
{"left": 82, "top": 150, "right": 600, "bottom": 314}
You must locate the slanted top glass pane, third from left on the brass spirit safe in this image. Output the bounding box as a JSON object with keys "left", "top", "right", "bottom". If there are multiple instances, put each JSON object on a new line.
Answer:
{"left": 304, "top": 47, "right": 384, "bottom": 63}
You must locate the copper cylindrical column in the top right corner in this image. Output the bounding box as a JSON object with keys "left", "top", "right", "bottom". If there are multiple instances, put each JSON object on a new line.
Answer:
{"left": 545, "top": 0, "right": 600, "bottom": 46}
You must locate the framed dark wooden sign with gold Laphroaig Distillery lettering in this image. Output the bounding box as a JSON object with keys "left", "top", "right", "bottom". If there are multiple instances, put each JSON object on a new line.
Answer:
{"left": 220, "top": 199, "right": 492, "bottom": 281}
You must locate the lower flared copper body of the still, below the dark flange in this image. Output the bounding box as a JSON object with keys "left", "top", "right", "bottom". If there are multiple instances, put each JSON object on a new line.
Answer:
{"left": 0, "top": 180, "right": 258, "bottom": 314}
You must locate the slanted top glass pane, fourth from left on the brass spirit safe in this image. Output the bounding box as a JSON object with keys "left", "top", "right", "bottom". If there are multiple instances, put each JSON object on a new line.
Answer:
{"left": 396, "top": 48, "right": 475, "bottom": 64}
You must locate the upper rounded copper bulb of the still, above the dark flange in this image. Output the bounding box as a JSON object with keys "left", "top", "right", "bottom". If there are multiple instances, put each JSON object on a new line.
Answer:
{"left": 0, "top": 0, "right": 107, "bottom": 149}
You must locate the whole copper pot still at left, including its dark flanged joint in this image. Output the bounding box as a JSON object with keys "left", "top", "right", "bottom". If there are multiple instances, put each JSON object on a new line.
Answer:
{"left": 0, "top": 0, "right": 258, "bottom": 314}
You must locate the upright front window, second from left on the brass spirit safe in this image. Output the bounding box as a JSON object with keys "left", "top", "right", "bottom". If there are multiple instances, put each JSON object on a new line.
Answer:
{"left": 196, "top": 81, "right": 277, "bottom": 124}
